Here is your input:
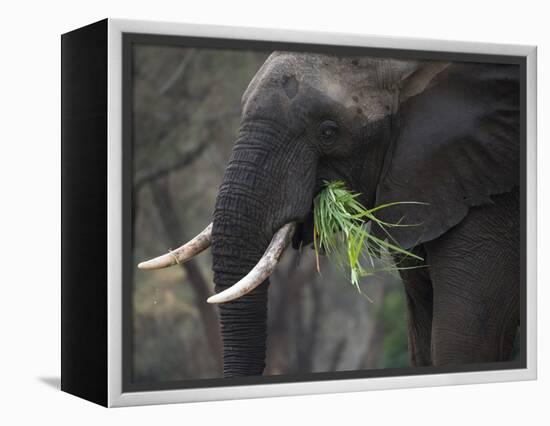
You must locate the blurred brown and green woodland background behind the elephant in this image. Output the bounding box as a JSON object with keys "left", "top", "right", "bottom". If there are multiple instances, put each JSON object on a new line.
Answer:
{"left": 132, "top": 45, "right": 408, "bottom": 383}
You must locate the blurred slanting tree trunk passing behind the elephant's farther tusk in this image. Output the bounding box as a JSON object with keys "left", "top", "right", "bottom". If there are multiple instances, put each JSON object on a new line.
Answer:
{"left": 151, "top": 179, "right": 222, "bottom": 373}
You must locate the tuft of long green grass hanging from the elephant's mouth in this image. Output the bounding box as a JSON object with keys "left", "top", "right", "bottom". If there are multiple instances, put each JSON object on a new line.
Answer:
{"left": 313, "top": 181, "right": 424, "bottom": 300}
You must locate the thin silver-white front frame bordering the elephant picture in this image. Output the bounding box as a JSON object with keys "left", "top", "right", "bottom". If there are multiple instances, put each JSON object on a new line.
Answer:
{"left": 61, "top": 19, "right": 537, "bottom": 407}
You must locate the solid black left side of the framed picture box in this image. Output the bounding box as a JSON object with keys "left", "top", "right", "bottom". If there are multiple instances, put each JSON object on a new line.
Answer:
{"left": 60, "top": 19, "right": 108, "bottom": 406}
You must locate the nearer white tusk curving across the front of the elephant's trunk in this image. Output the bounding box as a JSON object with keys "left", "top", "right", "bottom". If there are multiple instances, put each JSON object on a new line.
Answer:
{"left": 207, "top": 222, "right": 296, "bottom": 303}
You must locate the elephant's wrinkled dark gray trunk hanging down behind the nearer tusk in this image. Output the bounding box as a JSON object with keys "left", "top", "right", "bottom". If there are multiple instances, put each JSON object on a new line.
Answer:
{"left": 212, "top": 120, "right": 308, "bottom": 377}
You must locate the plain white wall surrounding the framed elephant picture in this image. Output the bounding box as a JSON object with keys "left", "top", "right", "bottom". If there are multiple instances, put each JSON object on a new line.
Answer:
{"left": 0, "top": 0, "right": 550, "bottom": 426}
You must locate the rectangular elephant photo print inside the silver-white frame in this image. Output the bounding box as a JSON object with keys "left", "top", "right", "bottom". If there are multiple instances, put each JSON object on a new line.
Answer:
{"left": 125, "top": 43, "right": 524, "bottom": 388}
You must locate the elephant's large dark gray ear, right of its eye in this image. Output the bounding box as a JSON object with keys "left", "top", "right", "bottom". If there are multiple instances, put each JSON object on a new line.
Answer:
{"left": 374, "top": 63, "right": 520, "bottom": 249}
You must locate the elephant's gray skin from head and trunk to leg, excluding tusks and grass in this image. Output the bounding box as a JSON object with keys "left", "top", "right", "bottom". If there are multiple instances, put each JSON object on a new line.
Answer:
{"left": 212, "top": 52, "right": 520, "bottom": 376}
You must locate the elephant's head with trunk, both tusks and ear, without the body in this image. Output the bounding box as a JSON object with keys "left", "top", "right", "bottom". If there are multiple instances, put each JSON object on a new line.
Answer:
{"left": 141, "top": 52, "right": 519, "bottom": 376}
